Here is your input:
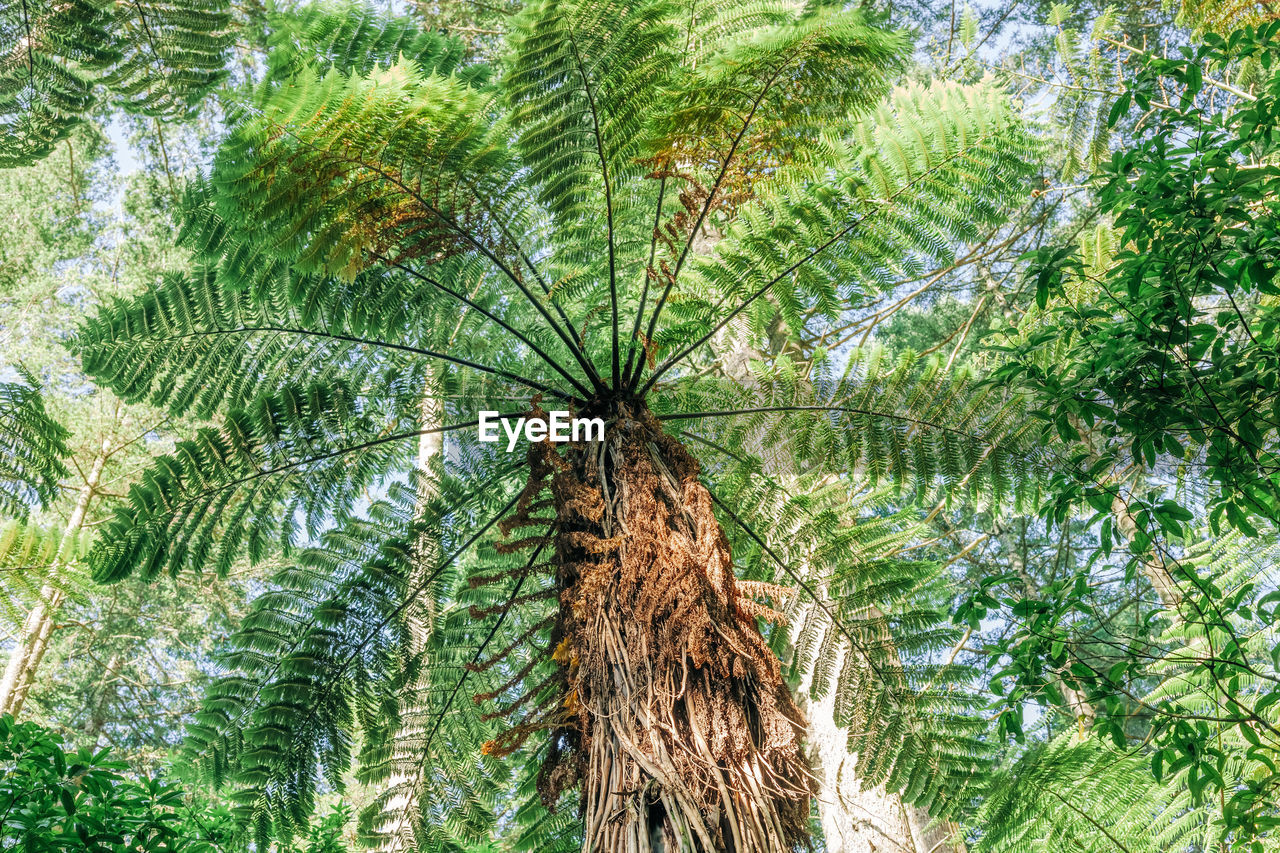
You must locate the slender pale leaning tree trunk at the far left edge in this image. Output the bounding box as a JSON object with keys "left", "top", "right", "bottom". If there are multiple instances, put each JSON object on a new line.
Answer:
{"left": 0, "top": 441, "right": 110, "bottom": 717}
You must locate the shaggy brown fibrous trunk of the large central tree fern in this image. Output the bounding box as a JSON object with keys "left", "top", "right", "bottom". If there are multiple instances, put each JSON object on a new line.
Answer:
{"left": 488, "top": 403, "right": 812, "bottom": 853}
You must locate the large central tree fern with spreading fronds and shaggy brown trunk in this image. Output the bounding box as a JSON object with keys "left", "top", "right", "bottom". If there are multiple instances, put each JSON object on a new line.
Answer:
{"left": 77, "top": 0, "right": 1044, "bottom": 852}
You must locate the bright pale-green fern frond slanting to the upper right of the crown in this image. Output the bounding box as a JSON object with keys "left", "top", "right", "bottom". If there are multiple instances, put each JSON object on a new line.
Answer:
{"left": 655, "top": 74, "right": 1033, "bottom": 364}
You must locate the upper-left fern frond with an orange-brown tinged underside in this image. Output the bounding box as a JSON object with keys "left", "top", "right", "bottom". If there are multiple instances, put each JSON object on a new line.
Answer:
{"left": 212, "top": 63, "right": 507, "bottom": 278}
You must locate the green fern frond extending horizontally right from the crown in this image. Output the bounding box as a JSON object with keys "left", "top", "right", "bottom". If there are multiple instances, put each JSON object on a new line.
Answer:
{"left": 655, "top": 347, "right": 1044, "bottom": 506}
